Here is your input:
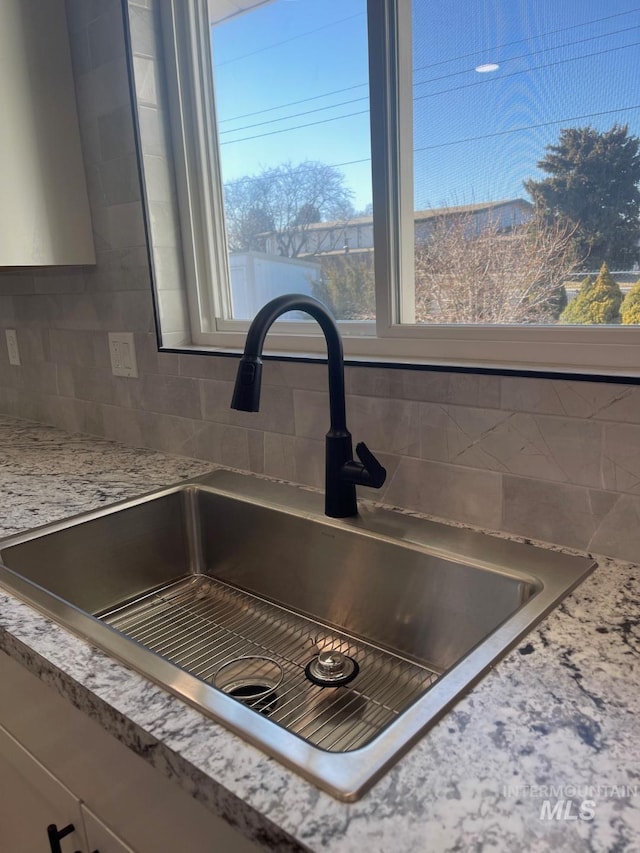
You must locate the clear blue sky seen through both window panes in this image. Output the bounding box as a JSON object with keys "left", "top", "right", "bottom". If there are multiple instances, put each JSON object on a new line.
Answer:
{"left": 212, "top": 0, "right": 640, "bottom": 209}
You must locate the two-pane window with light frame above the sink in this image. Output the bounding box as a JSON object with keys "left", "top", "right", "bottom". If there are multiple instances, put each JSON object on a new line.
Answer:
{"left": 145, "top": 0, "right": 640, "bottom": 375}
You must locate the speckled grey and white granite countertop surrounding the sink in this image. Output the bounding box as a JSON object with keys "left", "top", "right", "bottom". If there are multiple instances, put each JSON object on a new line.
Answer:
{"left": 0, "top": 416, "right": 640, "bottom": 853}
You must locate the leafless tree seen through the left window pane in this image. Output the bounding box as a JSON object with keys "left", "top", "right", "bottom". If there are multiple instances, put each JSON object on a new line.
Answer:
{"left": 225, "top": 161, "right": 353, "bottom": 258}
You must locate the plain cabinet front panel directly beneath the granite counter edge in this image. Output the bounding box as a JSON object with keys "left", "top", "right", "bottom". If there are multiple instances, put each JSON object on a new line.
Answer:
{"left": 0, "top": 656, "right": 261, "bottom": 853}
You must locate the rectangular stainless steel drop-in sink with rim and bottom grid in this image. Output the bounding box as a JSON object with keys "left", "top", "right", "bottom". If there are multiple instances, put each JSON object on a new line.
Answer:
{"left": 0, "top": 470, "right": 595, "bottom": 800}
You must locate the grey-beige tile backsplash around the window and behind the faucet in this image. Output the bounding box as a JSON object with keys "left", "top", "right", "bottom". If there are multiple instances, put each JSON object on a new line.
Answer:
{"left": 0, "top": 0, "right": 640, "bottom": 561}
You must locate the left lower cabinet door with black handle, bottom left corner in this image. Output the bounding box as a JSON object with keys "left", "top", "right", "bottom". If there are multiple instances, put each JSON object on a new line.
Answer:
{"left": 0, "top": 726, "right": 87, "bottom": 853}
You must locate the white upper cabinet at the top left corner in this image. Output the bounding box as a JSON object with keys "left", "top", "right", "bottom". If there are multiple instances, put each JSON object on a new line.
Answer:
{"left": 0, "top": 0, "right": 95, "bottom": 267}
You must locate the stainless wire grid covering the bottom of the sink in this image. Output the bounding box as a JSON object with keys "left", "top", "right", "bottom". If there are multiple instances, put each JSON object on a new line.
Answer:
{"left": 100, "top": 575, "right": 439, "bottom": 752}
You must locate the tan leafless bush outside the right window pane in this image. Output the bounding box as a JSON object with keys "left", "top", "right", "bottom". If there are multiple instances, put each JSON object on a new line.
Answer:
{"left": 416, "top": 213, "right": 578, "bottom": 324}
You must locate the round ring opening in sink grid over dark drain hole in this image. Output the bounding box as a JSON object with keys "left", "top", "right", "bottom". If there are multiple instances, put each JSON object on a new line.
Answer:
{"left": 213, "top": 656, "right": 284, "bottom": 715}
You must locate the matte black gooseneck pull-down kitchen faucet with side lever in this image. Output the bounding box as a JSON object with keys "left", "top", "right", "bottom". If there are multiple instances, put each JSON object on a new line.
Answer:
{"left": 231, "top": 293, "right": 387, "bottom": 518}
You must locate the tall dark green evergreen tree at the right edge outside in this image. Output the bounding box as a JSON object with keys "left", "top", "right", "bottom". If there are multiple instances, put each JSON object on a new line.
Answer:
{"left": 524, "top": 124, "right": 640, "bottom": 269}
